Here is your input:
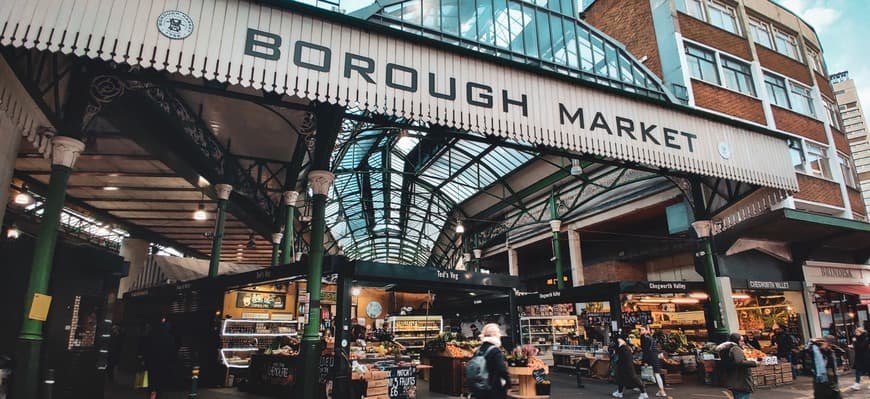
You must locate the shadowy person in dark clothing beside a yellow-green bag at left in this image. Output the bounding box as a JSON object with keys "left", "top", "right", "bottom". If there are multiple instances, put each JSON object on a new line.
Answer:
{"left": 142, "top": 319, "right": 177, "bottom": 399}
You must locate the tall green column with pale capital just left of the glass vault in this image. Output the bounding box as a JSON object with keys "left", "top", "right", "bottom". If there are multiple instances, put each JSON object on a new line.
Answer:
{"left": 299, "top": 103, "right": 344, "bottom": 398}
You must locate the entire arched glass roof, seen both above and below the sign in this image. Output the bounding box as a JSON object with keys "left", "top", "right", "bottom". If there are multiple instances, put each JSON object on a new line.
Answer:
{"left": 326, "top": 0, "right": 669, "bottom": 267}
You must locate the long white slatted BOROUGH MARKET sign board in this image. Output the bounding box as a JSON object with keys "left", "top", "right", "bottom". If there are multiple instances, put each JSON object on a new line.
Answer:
{"left": 0, "top": 0, "right": 797, "bottom": 190}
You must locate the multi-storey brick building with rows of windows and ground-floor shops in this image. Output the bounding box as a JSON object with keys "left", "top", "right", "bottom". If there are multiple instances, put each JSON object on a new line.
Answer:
{"left": 581, "top": 0, "right": 870, "bottom": 340}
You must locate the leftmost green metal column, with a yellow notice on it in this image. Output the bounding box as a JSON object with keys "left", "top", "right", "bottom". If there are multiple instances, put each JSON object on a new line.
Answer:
{"left": 13, "top": 136, "right": 85, "bottom": 399}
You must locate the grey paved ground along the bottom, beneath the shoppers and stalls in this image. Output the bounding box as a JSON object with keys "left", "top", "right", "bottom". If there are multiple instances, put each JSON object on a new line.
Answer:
{"left": 106, "top": 373, "right": 870, "bottom": 399}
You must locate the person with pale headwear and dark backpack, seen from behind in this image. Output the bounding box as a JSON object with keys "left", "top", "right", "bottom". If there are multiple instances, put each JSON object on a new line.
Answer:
{"left": 465, "top": 323, "right": 511, "bottom": 399}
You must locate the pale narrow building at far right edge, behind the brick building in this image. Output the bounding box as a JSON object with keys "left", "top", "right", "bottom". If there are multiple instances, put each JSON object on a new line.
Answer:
{"left": 831, "top": 71, "right": 870, "bottom": 216}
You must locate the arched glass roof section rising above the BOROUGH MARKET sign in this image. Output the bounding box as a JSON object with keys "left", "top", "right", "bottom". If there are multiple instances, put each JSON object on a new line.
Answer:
{"left": 355, "top": 0, "right": 669, "bottom": 100}
